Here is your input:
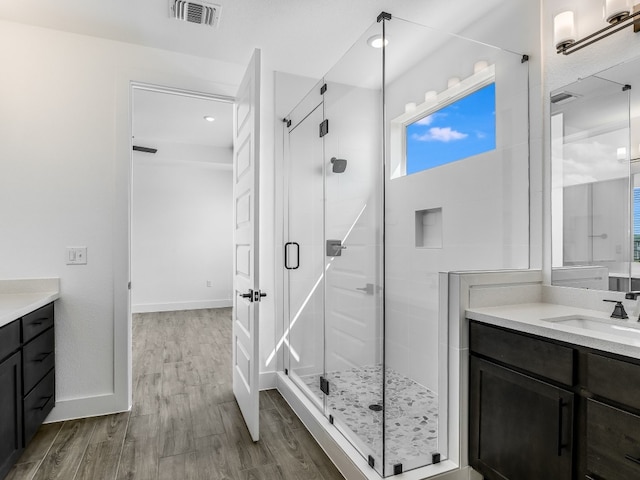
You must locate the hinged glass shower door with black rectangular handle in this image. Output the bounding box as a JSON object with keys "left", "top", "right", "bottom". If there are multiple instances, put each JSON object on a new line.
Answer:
{"left": 284, "top": 87, "right": 325, "bottom": 408}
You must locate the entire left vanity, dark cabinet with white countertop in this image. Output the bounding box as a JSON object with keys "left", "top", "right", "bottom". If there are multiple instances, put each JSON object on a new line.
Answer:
{"left": 0, "top": 279, "right": 59, "bottom": 478}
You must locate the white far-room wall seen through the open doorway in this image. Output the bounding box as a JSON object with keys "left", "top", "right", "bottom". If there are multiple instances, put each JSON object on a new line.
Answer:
{"left": 131, "top": 145, "right": 233, "bottom": 313}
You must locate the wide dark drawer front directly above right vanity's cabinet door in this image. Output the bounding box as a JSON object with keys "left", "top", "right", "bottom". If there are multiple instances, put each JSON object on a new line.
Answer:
{"left": 469, "top": 322, "right": 574, "bottom": 385}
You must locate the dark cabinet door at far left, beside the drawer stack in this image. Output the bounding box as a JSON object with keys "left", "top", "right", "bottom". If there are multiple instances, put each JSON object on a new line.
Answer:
{"left": 0, "top": 352, "right": 22, "bottom": 478}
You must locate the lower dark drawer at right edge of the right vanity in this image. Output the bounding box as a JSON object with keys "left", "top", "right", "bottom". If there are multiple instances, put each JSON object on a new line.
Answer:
{"left": 587, "top": 400, "right": 640, "bottom": 480}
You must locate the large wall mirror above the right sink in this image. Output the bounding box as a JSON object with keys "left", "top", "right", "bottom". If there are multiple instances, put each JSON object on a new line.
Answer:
{"left": 551, "top": 55, "right": 640, "bottom": 291}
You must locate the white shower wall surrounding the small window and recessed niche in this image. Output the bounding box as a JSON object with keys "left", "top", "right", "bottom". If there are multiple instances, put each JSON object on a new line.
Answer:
{"left": 385, "top": 39, "right": 530, "bottom": 393}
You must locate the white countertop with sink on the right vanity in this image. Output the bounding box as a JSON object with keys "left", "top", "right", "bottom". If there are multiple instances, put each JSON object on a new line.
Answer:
{"left": 466, "top": 303, "right": 640, "bottom": 359}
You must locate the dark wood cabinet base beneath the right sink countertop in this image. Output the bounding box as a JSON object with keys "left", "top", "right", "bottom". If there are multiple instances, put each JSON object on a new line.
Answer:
{"left": 469, "top": 321, "right": 640, "bottom": 480}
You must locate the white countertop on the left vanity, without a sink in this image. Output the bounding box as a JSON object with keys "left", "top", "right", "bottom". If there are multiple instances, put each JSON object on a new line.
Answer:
{"left": 0, "top": 278, "right": 60, "bottom": 327}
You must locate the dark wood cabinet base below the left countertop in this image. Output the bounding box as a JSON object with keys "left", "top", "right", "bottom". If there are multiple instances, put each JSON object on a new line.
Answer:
{"left": 0, "top": 303, "right": 55, "bottom": 479}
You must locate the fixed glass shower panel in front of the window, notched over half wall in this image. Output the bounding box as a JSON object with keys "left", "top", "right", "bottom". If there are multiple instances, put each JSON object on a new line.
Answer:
{"left": 384, "top": 17, "right": 529, "bottom": 475}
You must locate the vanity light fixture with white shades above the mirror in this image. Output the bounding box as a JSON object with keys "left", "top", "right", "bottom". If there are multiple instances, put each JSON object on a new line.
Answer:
{"left": 553, "top": 0, "right": 640, "bottom": 55}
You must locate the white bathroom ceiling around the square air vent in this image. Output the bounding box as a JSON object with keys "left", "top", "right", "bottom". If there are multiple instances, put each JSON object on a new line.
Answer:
{"left": 0, "top": 0, "right": 505, "bottom": 78}
